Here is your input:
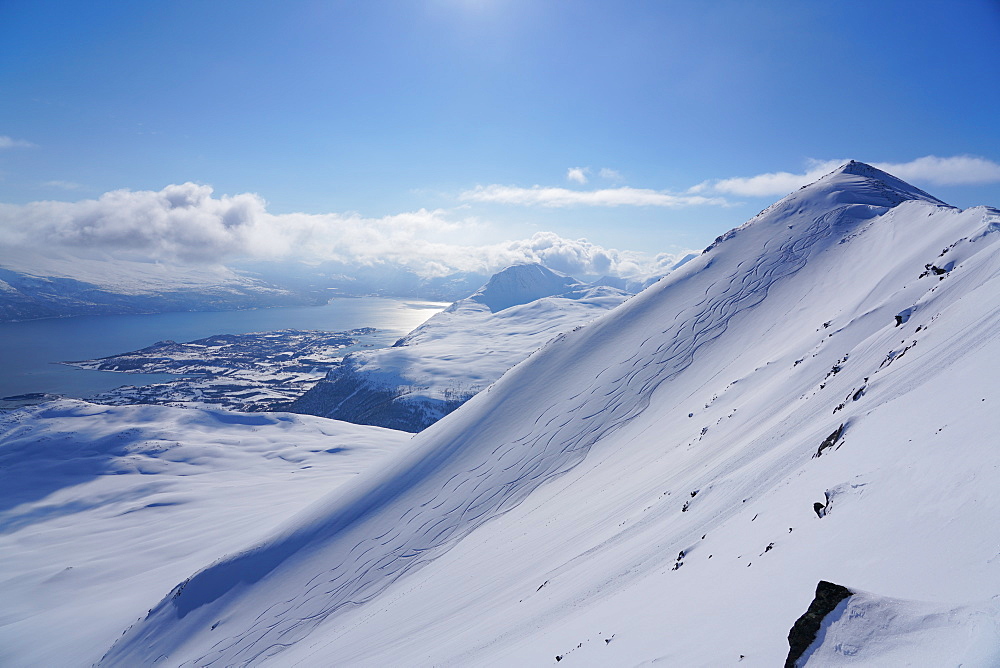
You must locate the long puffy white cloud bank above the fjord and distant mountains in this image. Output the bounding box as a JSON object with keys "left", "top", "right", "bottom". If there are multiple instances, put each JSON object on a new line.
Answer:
{"left": 0, "top": 183, "right": 680, "bottom": 277}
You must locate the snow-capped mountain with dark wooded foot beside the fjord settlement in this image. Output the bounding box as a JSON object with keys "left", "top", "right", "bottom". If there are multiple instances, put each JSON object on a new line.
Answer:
{"left": 287, "top": 264, "right": 628, "bottom": 432}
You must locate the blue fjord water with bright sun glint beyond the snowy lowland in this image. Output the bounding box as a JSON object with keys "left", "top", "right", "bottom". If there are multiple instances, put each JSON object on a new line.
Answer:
{"left": 0, "top": 297, "right": 447, "bottom": 398}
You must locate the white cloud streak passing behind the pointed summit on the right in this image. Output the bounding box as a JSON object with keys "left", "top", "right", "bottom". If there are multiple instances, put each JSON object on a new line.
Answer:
{"left": 704, "top": 155, "right": 1000, "bottom": 197}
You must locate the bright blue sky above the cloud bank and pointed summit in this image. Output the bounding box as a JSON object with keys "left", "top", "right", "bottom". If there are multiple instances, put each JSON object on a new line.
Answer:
{"left": 0, "top": 0, "right": 1000, "bottom": 274}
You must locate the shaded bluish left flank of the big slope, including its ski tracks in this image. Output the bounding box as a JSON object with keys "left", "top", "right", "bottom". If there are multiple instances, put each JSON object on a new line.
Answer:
{"left": 105, "top": 166, "right": 900, "bottom": 666}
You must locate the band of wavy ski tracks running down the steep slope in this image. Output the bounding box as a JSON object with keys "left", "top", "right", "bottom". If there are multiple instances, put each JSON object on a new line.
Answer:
{"left": 174, "top": 207, "right": 848, "bottom": 666}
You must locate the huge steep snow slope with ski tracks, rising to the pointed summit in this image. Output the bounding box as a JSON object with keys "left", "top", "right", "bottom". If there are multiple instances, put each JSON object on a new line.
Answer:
{"left": 88, "top": 162, "right": 1000, "bottom": 666}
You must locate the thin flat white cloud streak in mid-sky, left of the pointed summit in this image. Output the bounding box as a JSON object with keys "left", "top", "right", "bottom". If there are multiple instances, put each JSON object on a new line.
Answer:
{"left": 459, "top": 184, "right": 726, "bottom": 208}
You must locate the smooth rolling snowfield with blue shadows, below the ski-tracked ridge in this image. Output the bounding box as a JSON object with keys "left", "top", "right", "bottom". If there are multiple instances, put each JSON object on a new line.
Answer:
{"left": 0, "top": 400, "right": 409, "bottom": 666}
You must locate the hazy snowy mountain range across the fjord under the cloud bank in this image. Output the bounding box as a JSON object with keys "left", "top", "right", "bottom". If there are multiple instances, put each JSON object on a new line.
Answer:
{"left": 0, "top": 250, "right": 486, "bottom": 322}
